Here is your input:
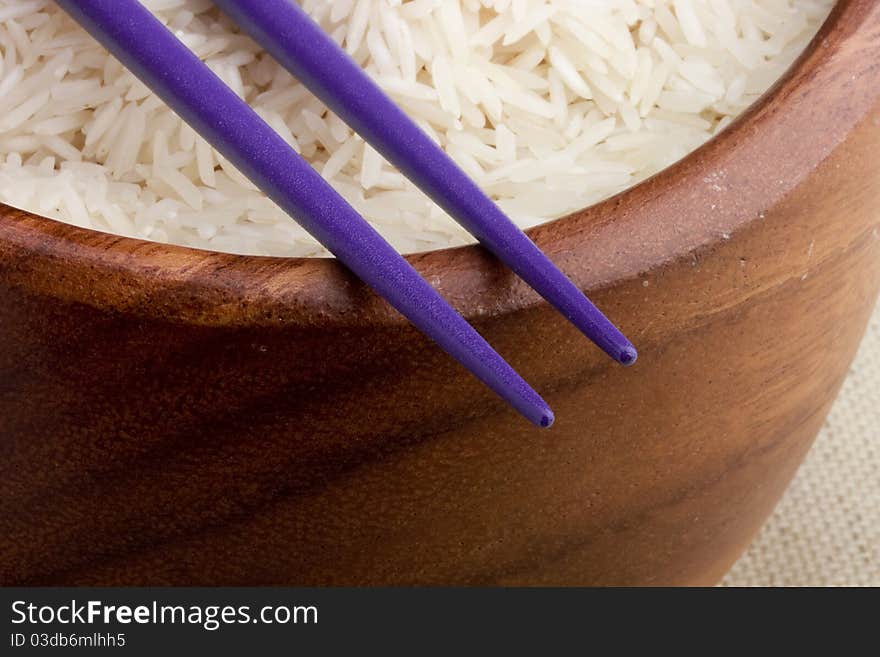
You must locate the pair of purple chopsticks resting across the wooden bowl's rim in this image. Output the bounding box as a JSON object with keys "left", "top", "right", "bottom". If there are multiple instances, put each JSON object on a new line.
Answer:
{"left": 56, "top": 0, "right": 636, "bottom": 427}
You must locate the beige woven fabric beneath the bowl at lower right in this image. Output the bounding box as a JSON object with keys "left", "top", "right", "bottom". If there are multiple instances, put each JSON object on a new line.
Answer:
{"left": 723, "top": 306, "right": 880, "bottom": 586}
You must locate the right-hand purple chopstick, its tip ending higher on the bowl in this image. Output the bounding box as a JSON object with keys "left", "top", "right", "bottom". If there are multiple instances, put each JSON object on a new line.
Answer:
{"left": 214, "top": 0, "right": 637, "bottom": 365}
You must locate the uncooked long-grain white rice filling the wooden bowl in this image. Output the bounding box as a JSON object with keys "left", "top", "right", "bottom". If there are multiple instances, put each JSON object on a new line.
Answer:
{"left": 0, "top": 0, "right": 833, "bottom": 256}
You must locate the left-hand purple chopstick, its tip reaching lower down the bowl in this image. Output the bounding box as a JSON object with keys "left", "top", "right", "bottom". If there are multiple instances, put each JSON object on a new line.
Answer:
{"left": 57, "top": 0, "right": 553, "bottom": 427}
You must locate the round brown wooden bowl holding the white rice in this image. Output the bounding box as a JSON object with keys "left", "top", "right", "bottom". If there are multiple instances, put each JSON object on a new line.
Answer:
{"left": 0, "top": 0, "right": 880, "bottom": 585}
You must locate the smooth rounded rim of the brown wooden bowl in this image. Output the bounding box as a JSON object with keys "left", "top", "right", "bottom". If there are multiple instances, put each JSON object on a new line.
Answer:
{"left": 0, "top": 0, "right": 880, "bottom": 326}
